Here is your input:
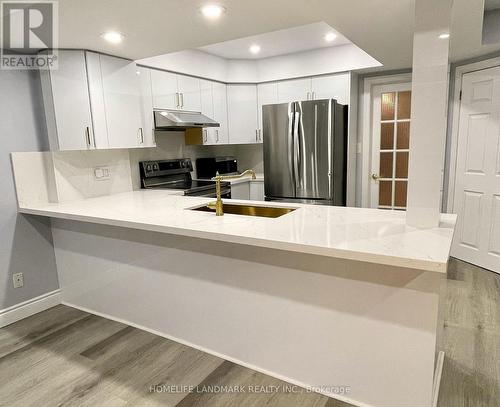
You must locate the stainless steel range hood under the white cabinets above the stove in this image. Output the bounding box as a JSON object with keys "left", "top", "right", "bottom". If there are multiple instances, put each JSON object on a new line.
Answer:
{"left": 154, "top": 110, "right": 220, "bottom": 130}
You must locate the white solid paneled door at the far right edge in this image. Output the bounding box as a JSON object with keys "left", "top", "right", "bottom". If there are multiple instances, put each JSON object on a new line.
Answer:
{"left": 452, "top": 67, "right": 500, "bottom": 273}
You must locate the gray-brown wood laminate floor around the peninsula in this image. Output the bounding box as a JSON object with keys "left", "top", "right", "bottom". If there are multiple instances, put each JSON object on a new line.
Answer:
{"left": 0, "top": 260, "right": 500, "bottom": 407}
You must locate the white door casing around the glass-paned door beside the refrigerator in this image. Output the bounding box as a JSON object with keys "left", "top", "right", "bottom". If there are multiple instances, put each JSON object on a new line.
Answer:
{"left": 357, "top": 72, "right": 412, "bottom": 208}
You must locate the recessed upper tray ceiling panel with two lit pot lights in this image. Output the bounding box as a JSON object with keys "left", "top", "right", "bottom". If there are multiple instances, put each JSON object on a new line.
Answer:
{"left": 198, "top": 22, "right": 351, "bottom": 59}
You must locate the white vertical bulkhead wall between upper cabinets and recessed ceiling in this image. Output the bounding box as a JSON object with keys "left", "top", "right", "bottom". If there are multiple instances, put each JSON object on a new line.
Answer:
{"left": 137, "top": 44, "right": 381, "bottom": 83}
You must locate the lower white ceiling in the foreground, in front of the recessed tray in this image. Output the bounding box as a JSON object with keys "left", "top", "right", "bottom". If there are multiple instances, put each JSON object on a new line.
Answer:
{"left": 53, "top": 0, "right": 413, "bottom": 69}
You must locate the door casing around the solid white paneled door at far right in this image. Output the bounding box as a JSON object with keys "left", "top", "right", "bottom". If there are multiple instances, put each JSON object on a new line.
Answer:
{"left": 445, "top": 57, "right": 500, "bottom": 213}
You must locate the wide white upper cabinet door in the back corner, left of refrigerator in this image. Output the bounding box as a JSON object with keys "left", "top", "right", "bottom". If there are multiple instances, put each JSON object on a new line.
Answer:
{"left": 227, "top": 85, "right": 258, "bottom": 144}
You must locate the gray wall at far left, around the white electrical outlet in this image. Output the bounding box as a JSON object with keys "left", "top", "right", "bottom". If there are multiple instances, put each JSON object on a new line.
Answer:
{"left": 0, "top": 70, "right": 59, "bottom": 310}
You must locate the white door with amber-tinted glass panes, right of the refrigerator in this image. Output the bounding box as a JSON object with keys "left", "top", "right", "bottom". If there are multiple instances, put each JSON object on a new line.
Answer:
{"left": 365, "top": 83, "right": 411, "bottom": 210}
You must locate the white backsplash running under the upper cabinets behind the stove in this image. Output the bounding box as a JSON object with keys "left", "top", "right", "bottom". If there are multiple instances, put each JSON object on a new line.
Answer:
{"left": 12, "top": 132, "right": 263, "bottom": 206}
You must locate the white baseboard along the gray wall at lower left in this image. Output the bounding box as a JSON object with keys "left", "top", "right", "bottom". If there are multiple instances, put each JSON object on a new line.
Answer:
{"left": 0, "top": 290, "right": 61, "bottom": 328}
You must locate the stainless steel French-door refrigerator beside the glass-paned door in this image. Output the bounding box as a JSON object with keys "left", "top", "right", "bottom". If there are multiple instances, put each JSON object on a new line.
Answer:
{"left": 262, "top": 99, "right": 347, "bottom": 206}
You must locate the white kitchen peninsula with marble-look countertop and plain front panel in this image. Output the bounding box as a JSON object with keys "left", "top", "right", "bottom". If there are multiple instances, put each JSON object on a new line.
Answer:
{"left": 12, "top": 180, "right": 455, "bottom": 407}
